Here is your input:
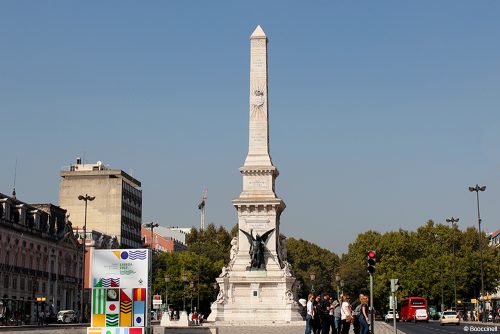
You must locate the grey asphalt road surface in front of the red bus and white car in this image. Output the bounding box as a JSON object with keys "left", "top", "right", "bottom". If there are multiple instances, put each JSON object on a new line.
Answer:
{"left": 398, "top": 321, "right": 500, "bottom": 334}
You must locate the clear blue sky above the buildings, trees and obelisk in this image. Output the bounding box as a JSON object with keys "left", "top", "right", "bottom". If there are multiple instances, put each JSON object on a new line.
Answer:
{"left": 0, "top": 0, "right": 500, "bottom": 253}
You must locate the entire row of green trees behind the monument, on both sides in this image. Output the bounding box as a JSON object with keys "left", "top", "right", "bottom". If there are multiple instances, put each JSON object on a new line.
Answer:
{"left": 149, "top": 220, "right": 500, "bottom": 313}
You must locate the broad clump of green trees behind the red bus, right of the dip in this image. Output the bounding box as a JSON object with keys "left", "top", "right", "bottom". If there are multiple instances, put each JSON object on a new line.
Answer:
{"left": 341, "top": 220, "right": 500, "bottom": 309}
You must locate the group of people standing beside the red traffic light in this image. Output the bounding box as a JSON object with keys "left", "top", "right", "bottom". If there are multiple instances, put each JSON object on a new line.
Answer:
{"left": 305, "top": 293, "right": 370, "bottom": 334}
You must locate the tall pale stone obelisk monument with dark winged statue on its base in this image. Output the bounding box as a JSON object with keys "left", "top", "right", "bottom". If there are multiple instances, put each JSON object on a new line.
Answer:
{"left": 208, "top": 26, "right": 302, "bottom": 325}
